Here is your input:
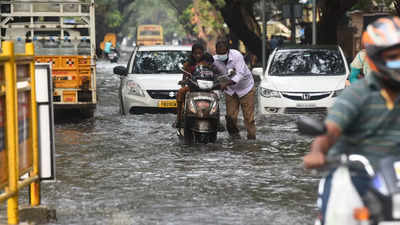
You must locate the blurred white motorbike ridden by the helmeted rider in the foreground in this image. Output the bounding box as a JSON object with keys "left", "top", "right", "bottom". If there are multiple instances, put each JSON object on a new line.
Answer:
{"left": 297, "top": 117, "right": 400, "bottom": 225}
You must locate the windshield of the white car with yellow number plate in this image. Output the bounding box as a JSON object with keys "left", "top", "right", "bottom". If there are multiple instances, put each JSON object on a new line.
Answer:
{"left": 132, "top": 51, "right": 190, "bottom": 74}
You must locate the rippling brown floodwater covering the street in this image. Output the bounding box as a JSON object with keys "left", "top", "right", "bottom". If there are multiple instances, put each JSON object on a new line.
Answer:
{"left": 42, "top": 61, "right": 318, "bottom": 225}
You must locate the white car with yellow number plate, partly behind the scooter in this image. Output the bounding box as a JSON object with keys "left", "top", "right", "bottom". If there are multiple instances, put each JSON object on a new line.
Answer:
{"left": 114, "top": 45, "right": 191, "bottom": 114}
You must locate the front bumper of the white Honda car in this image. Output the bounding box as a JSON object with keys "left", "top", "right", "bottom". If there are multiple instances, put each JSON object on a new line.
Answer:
{"left": 257, "top": 95, "right": 336, "bottom": 114}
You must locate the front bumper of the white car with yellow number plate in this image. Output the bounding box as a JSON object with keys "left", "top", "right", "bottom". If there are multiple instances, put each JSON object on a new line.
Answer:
{"left": 122, "top": 95, "right": 176, "bottom": 114}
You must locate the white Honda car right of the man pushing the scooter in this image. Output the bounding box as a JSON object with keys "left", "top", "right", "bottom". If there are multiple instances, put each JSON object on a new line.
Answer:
{"left": 253, "top": 45, "right": 349, "bottom": 114}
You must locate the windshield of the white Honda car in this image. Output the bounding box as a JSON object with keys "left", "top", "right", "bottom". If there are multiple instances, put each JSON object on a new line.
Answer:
{"left": 269, "top": 49, "right": 346, "bottom": 76}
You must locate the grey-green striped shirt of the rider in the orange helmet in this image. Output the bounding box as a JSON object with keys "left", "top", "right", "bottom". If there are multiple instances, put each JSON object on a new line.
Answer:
{"left": 326, "top": 74, "right": 400, "bottom": 166}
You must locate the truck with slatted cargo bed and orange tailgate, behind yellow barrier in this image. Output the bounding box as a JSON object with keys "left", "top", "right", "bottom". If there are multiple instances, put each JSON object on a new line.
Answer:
{"left": 0, "top": 0, "right": 97, "bottom": 117}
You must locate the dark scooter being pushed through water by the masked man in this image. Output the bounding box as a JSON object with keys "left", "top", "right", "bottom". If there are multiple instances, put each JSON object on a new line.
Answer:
{"left": 177, "top": 65, "right": 227, "bottom": 144}
